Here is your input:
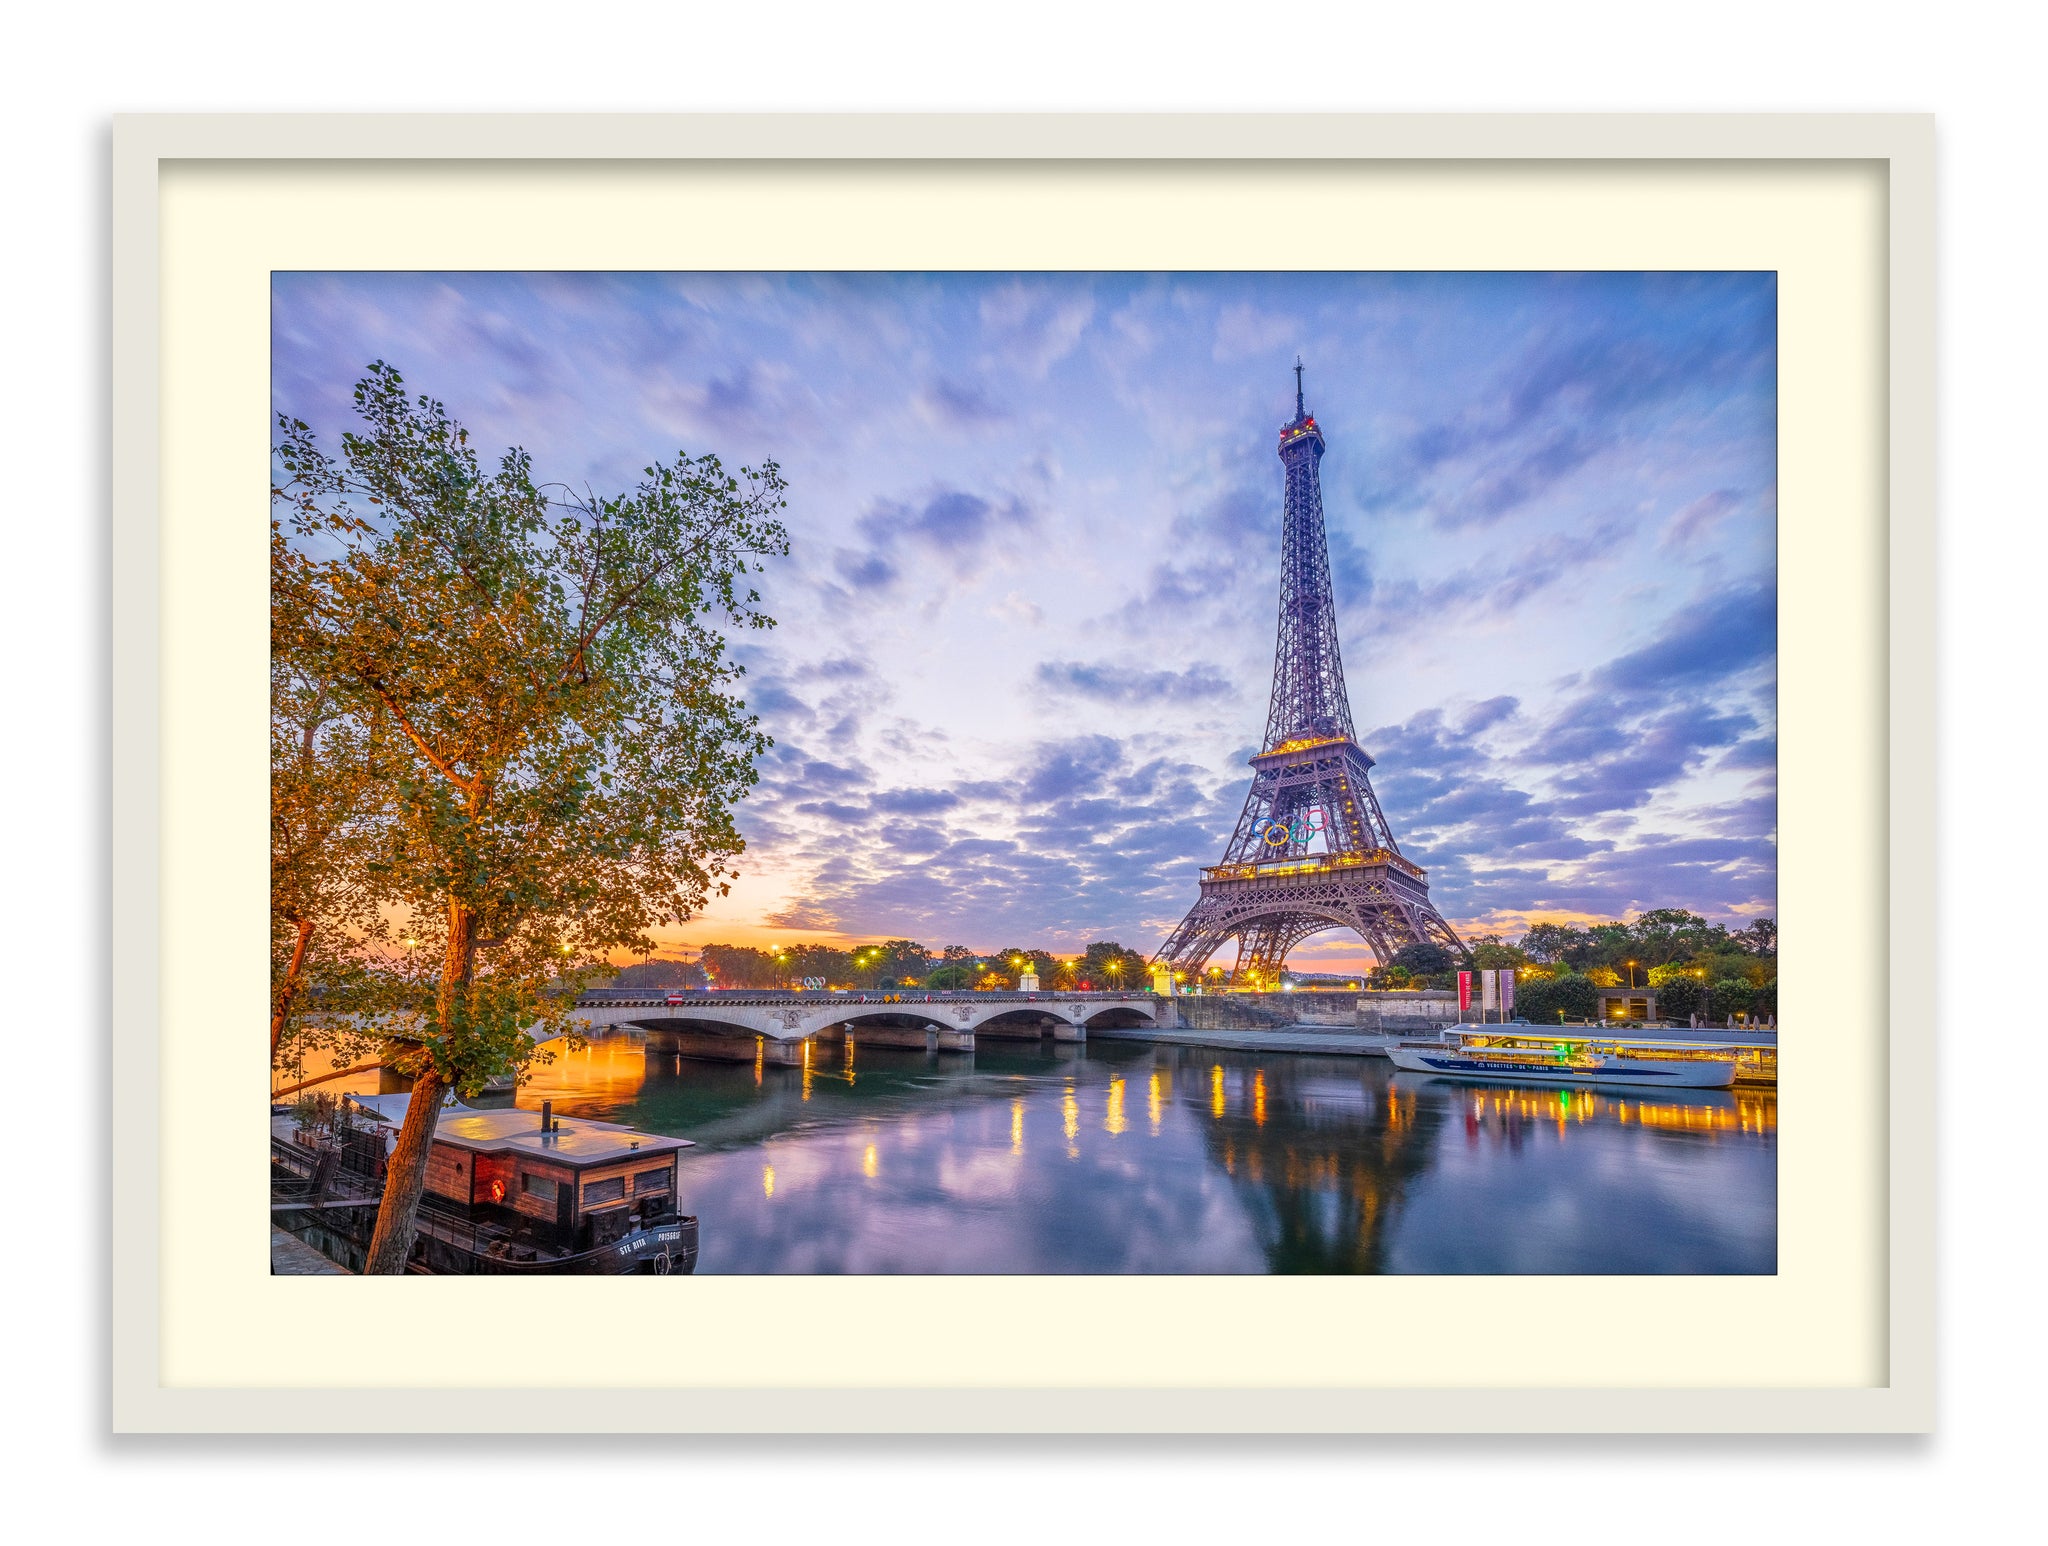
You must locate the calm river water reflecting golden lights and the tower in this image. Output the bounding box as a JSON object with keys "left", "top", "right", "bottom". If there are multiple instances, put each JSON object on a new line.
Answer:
{"left": 460, "top": 1032, "right": 1778, "bottom": 1274}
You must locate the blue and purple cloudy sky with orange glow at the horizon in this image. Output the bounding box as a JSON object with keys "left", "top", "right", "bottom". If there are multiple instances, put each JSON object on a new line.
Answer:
{"left": 272, "top": 272, "right": 1778, "bottom": 971}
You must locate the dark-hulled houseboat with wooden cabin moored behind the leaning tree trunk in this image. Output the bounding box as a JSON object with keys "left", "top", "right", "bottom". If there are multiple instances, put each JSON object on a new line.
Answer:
{"left": 270, "top": 1096, "right": 696, "bottom": 1274}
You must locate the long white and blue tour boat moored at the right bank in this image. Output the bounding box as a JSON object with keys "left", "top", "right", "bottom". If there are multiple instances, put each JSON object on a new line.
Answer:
{"left": 1386, "top": 1026, "right": 1737, "bottom": 1089}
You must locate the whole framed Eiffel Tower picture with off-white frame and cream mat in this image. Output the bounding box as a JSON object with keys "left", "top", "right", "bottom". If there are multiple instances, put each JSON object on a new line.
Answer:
{"left": 113, "top": 117, "right": 1933, "bottom": 1433}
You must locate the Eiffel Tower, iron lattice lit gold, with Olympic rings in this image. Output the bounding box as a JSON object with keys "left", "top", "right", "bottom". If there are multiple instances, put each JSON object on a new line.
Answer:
{"left": 1153, "top": 360, "right": 1464, "bottom": 985}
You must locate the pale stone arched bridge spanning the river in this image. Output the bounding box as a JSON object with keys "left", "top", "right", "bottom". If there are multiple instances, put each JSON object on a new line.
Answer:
{"left": 575, "top": 989, "right": 1178, "bottom": 1065}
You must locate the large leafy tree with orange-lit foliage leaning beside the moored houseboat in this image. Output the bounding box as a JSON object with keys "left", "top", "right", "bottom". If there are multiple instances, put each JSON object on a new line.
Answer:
{"left": 272, "top": 362, "right": 788, "bottom": 1274}
